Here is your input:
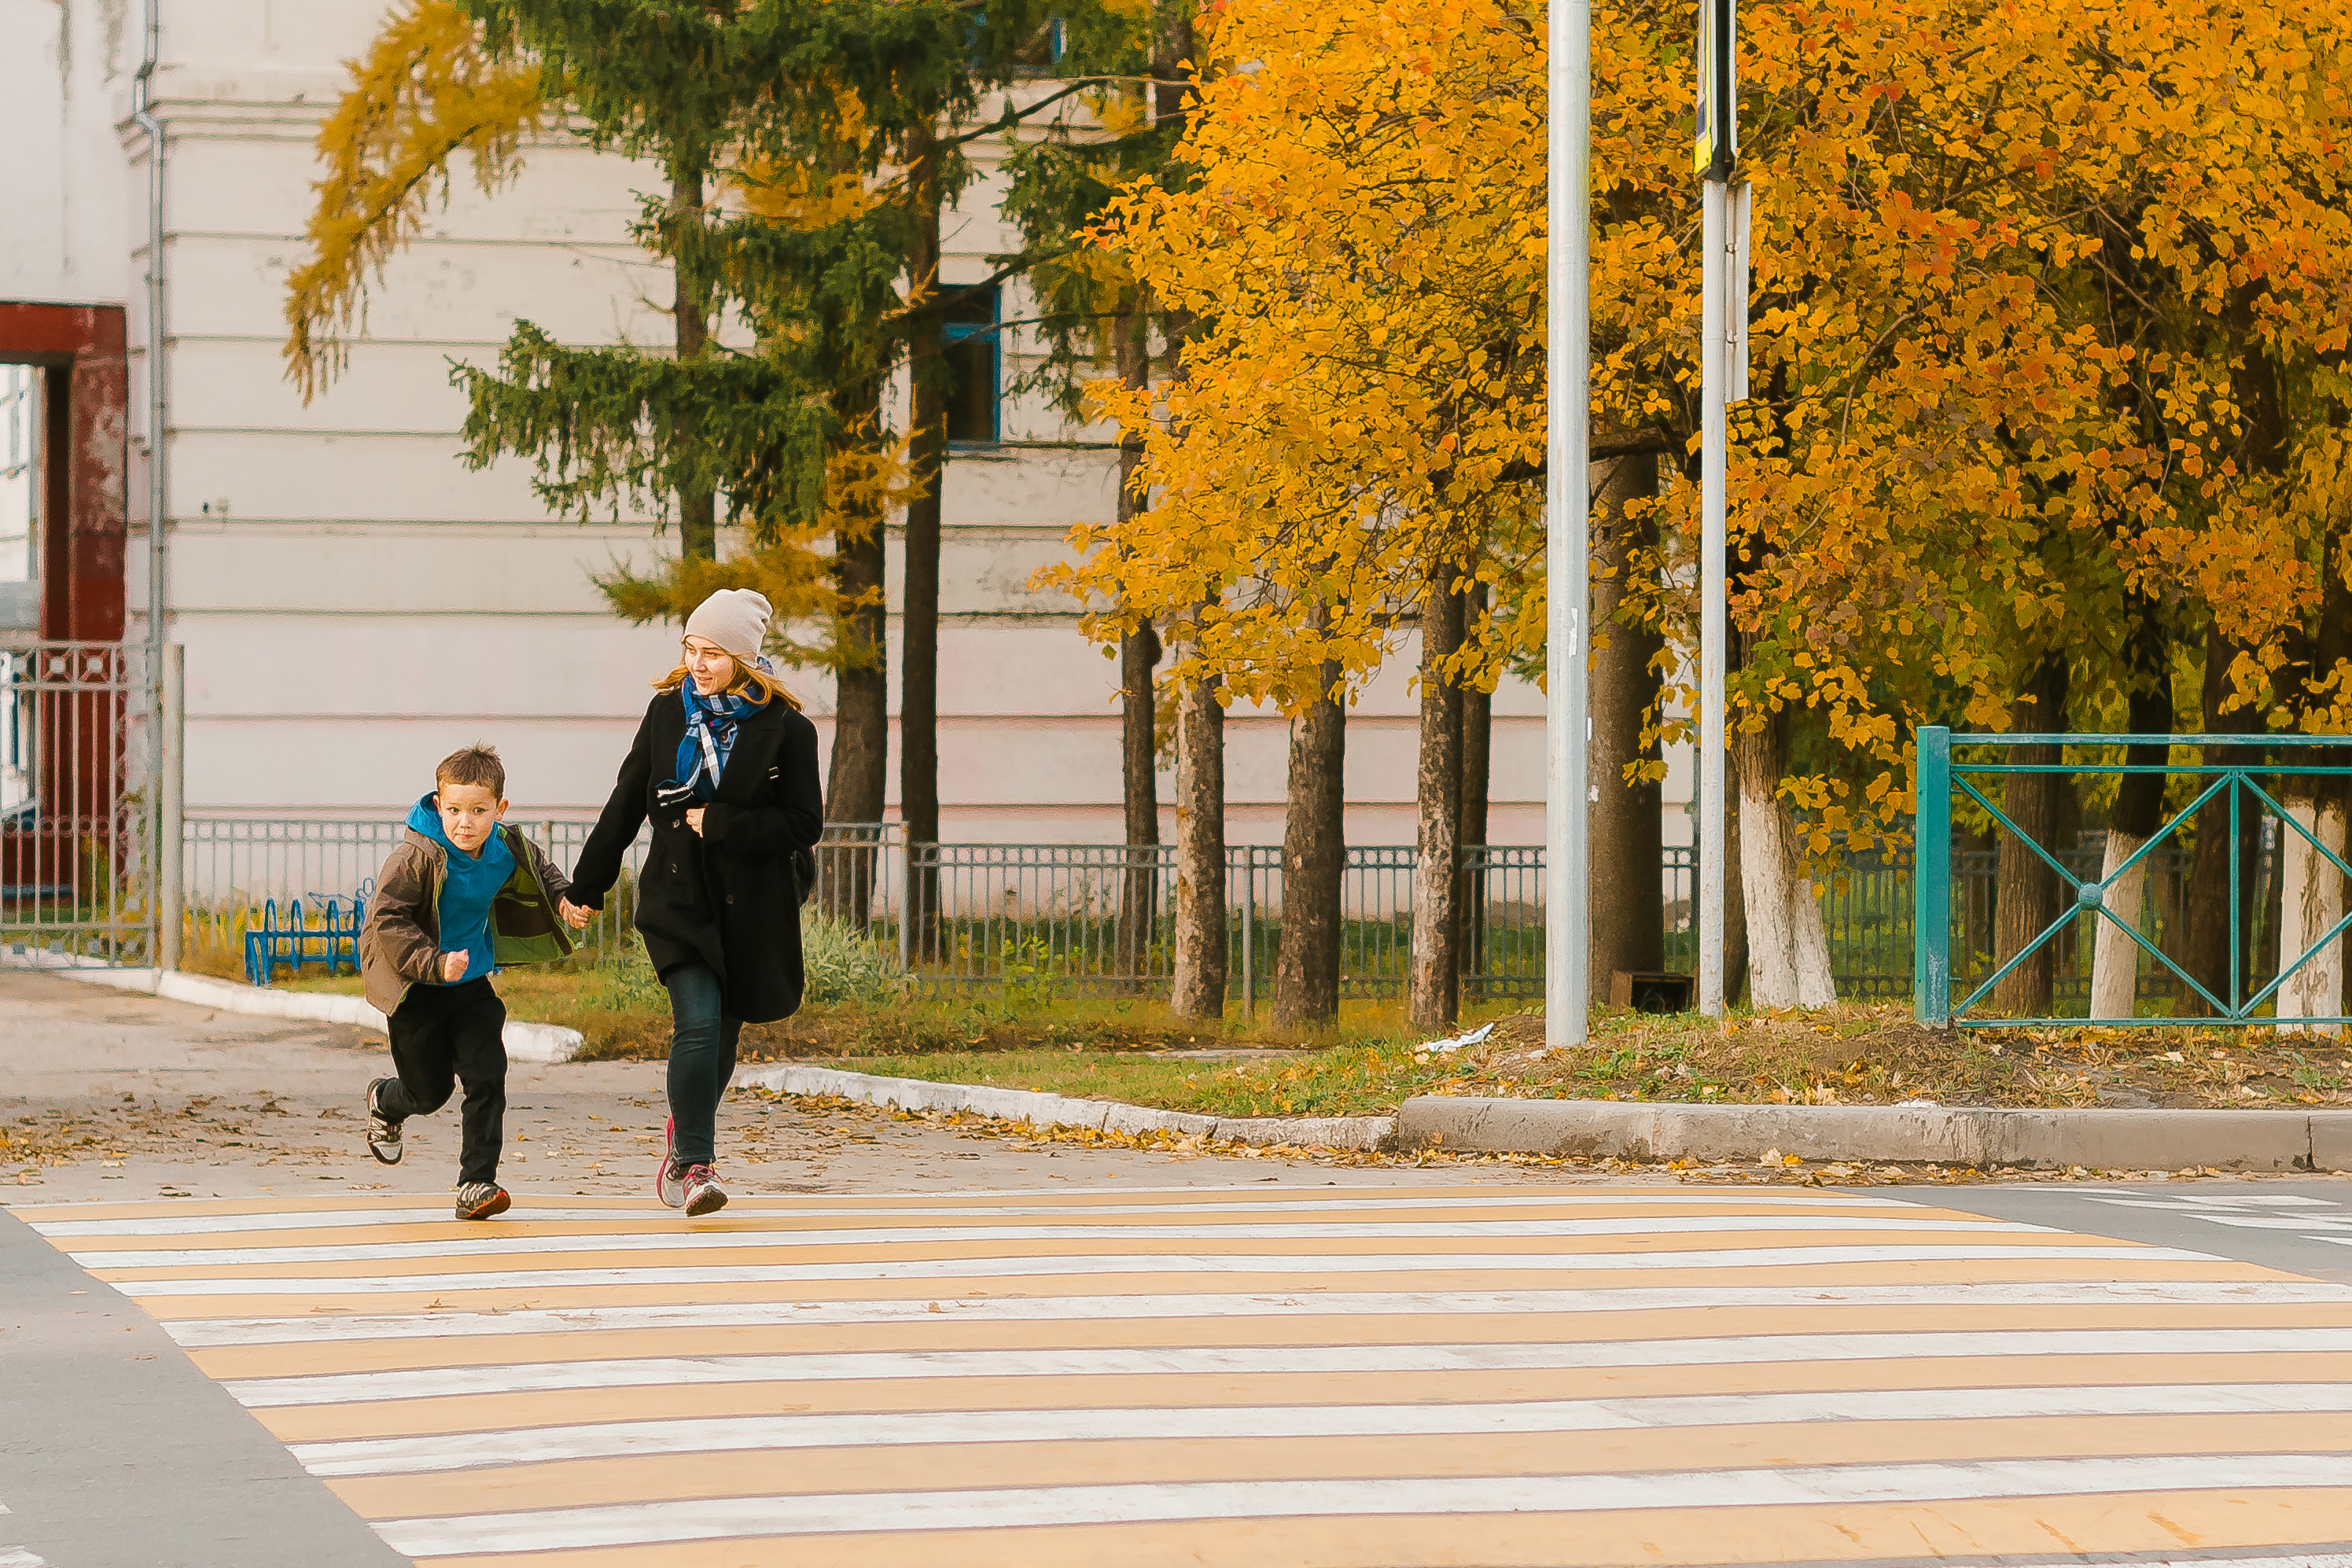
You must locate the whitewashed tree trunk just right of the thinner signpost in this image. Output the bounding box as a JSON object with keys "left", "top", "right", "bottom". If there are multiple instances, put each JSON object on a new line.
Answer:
{"left": 1731, "top": 712, "right": 1837, "bottom": 1008}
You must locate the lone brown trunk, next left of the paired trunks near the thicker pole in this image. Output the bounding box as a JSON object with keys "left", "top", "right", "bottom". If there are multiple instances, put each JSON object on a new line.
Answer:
{"left": 1275, "top": 653, "right": 1348, "bottom": 1029}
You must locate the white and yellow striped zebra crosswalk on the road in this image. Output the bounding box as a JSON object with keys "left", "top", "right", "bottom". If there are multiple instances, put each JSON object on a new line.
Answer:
{"left": 17, "top": 1187, "right": 2352, "bottom": 1568}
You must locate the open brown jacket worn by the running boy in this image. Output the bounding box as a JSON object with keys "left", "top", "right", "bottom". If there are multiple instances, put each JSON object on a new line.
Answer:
{"left": 360, "top": 823, "right": 572, "bottom": 1018}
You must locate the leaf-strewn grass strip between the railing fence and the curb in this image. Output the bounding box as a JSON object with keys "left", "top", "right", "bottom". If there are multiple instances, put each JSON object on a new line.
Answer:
{"left": 179, "top": 964, "right": 2352, "bottom": 1117}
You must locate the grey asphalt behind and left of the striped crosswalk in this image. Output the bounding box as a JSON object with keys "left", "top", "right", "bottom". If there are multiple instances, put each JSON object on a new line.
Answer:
{"left": 0, "top": 969, "right": 1552, "bottom": 1568}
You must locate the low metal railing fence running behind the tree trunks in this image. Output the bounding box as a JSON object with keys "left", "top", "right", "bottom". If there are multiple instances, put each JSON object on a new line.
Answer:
{"left": 183, "top": 815, "right": 1947, "bottom": 1008}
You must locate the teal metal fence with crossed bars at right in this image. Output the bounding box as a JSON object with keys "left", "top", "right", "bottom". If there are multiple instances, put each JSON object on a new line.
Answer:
{"left": 1912, "top": 727, "right": 2352, "bottom": 1027}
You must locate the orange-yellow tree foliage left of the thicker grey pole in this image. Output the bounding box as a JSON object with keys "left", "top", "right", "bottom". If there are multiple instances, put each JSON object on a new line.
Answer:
{"left": 1058, "top": 5, "right": 1543, "bottom": 708}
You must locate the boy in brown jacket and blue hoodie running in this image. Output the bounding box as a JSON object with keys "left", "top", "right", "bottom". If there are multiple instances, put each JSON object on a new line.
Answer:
{"left": 360, "top": 745, "right": 572, "bottom": 1220}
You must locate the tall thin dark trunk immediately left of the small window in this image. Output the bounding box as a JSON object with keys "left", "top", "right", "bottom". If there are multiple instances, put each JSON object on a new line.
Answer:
{"left": 899, "top": 169, "right": 948, "bottom": 959}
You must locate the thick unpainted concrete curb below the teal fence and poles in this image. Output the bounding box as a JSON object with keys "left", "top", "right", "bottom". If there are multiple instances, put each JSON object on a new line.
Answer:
{"left": 1395, "top": 1095, "right": 2352, "bottom": 1171}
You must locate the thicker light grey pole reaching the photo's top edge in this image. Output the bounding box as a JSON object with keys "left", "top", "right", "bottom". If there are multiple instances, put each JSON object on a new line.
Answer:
{"left": 1543, "top": 0, "right": 1592, "bottom": 1048}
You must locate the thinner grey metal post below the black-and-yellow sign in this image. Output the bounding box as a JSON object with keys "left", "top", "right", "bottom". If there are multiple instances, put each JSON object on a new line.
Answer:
{"left": 1699, "top": 179, "right": 1731, "bottom": 1018}
